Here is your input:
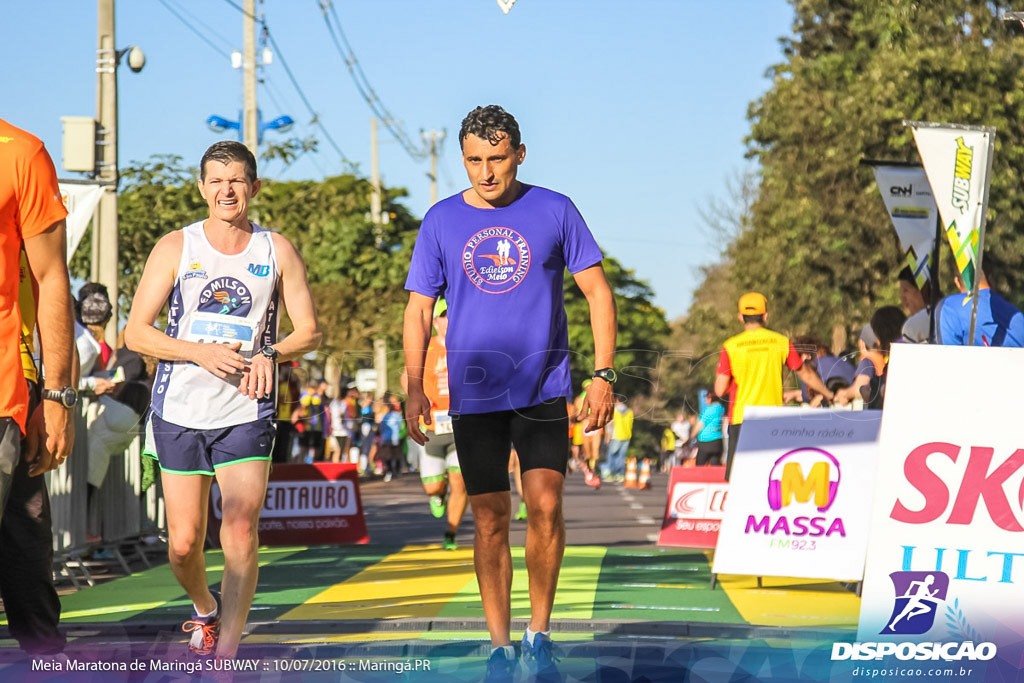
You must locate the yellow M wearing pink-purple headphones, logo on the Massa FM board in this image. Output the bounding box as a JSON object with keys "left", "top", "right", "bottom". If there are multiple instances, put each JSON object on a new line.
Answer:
{"left": 768, "top": 447, "right": 840, "bottom": 512}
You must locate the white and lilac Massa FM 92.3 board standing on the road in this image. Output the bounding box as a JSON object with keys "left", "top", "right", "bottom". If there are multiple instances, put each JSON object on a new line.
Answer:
{"left": 712, "top": 407, "right": 881, "bottom": 581}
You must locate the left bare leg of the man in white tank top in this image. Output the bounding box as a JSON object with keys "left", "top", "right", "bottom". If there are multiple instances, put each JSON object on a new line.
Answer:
{"left": 160, "top": 470, "right": 217, "bottom": 614}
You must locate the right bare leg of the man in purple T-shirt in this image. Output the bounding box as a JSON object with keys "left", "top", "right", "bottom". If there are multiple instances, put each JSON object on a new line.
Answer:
{"left": 524, "top": 468, "right": 565, "bottom": 632}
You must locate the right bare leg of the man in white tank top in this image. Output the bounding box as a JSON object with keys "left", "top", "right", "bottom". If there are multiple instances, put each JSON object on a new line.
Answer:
{"left": 211, "top": 460, "right": 270, "bottom": 657}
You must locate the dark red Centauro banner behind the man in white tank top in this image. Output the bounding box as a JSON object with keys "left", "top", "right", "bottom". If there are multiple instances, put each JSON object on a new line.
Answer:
{"left": 207, "top": 463, "right": 370, "bottom": 548}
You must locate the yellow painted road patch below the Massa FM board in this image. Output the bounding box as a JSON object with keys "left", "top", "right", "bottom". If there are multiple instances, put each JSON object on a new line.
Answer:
{"left": 718, "top": 574, "right": 860, "bottom": 628}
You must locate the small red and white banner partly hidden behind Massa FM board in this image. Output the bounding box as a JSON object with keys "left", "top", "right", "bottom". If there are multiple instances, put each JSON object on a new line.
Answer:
{"left": 657, "top": 466, "right": 729, "bottom": 548}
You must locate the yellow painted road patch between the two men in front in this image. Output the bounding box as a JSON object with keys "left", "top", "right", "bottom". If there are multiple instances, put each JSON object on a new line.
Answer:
{"left": 280, "top": 546, "right": 475, "bottom": 622}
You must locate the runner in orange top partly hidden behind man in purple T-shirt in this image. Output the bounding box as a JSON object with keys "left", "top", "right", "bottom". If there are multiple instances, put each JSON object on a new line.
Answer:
{"left": 420, "top": 299, "right": 469, "bottom": 550}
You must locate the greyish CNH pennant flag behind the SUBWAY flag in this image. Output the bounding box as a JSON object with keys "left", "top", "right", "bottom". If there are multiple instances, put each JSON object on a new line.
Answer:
{"left": 872, "top": 166, "right": 938, "bottom": 287}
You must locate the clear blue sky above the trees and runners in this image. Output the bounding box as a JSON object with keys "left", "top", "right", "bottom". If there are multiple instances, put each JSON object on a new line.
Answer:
{"left": 0, "top": 0, "right": 793, "bottom": 319}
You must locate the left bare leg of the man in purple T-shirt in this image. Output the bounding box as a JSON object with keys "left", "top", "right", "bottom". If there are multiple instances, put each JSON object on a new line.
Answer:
{"left": 469, "top": 490, "right": 512, "bottom": 647}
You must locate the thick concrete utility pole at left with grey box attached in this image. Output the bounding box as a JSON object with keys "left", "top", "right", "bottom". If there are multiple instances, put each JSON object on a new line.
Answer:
{"left": 92, "top": 0, "right": 119, "bottom": 346}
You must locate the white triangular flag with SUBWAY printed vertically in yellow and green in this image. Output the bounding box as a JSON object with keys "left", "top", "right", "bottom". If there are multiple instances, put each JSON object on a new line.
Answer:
{"left": 910, "top": 122, "right": 995, "bottom": 290}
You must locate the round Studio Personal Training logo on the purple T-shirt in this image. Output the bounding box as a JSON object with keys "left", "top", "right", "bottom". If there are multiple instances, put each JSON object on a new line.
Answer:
{"left": 462, "top": 227, "right": 530, "bottom": 294}
